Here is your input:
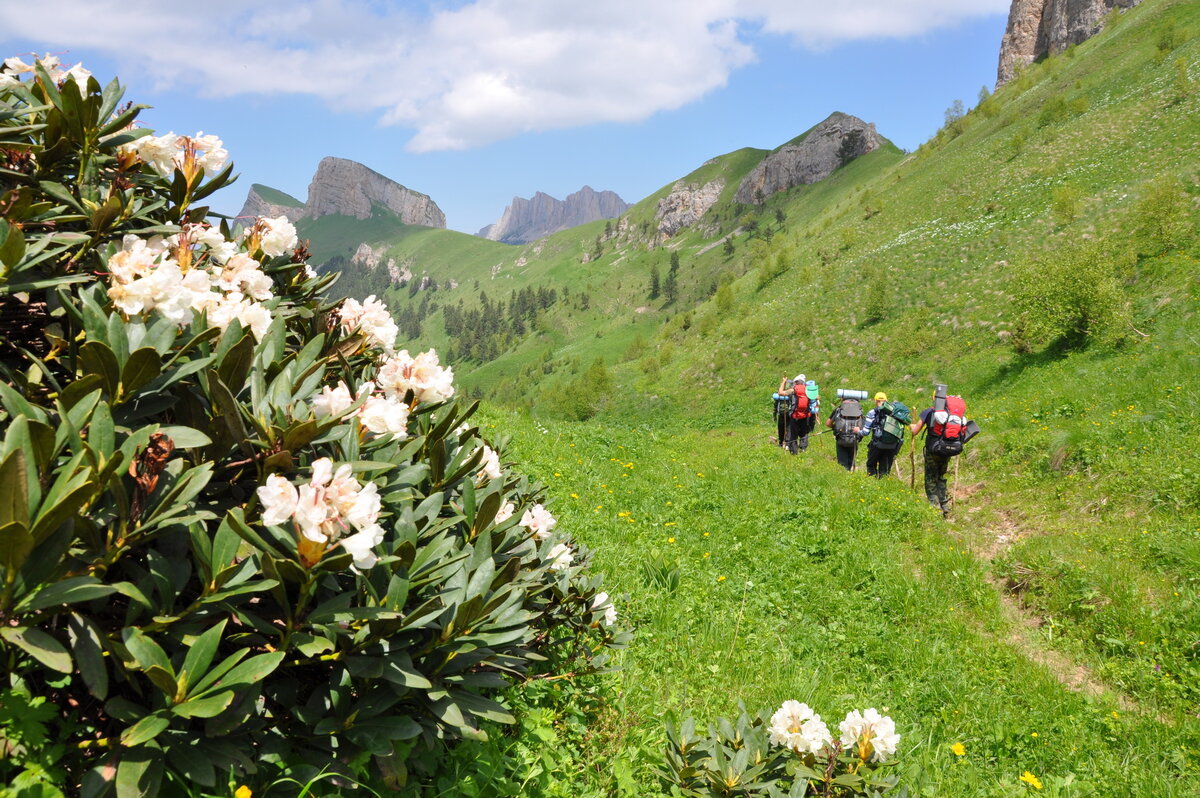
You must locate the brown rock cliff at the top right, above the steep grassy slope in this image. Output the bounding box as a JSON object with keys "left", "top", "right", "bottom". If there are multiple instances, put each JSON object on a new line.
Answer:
{"left": 996, "top": 0, "right": 1141, "bottom": 88}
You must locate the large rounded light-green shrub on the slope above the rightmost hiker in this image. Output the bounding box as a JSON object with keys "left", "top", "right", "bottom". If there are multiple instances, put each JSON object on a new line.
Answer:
{"left": 1012, "top": 236, "right": 1129, "bottom": 352}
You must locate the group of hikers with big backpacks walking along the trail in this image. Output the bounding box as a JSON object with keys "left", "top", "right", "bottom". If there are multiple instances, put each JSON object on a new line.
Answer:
{"left": 772, "top": 374, "right": 979, "bottom": 516}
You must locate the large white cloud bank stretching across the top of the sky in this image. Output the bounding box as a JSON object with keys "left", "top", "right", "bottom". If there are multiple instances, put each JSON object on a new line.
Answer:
{"left": 0, "top": 0, "right": 1008, "bottom": 152}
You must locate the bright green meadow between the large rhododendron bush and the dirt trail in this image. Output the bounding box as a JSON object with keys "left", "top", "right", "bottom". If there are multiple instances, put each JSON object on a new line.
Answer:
{"left": 488, "top": 413, "right": 1200, "bottom": 798}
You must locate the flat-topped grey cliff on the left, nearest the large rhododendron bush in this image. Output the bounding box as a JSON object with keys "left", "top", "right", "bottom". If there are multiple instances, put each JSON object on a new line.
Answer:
{"left": 239, "top": 158, "right": 446, "bottom": 228}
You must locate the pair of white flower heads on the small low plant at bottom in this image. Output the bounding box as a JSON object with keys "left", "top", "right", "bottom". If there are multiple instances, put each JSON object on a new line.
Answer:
{"left": 769, "top": 701, "right": 900, "bottom": 762}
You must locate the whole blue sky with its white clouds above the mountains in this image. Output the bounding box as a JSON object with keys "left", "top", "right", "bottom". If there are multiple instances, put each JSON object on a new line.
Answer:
{"left": 0, "top": 0, "right": 1008, "bottom": 233}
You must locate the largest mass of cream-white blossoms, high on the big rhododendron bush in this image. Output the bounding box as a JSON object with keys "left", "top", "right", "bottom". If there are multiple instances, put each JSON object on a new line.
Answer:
{"left": 108, "top": 228, "right": 274, "bottom": 338}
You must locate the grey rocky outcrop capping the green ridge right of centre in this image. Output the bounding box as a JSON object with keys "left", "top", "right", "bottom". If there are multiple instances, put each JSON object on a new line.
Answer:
{"left": 734, "top": 112, "right": 882, "bottom": 205}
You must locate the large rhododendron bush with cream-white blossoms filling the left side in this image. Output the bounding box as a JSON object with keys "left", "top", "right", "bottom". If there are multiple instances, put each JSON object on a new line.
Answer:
{"left": 0, "top": 59, "right": 626, "bottom": 798}
